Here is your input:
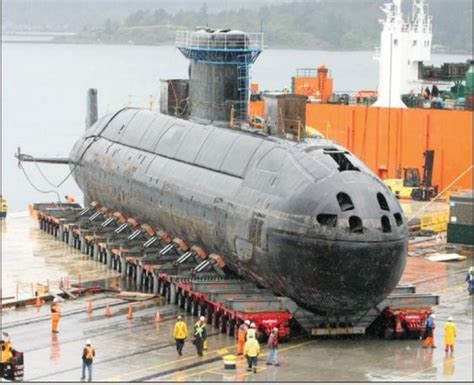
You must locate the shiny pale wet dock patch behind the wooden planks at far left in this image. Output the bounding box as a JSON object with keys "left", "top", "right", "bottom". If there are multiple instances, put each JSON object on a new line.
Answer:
{"left": 1, "top": 213, "right": 119, "bottom": 301}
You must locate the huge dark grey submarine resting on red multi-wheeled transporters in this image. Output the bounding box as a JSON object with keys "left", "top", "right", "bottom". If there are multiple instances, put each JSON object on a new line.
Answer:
{"left": 25, "top": 28, "right": 408, "bottom": 314}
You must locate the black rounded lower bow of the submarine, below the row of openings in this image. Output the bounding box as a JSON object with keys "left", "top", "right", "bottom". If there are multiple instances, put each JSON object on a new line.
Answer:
{"left": 267, "top": 228, "right": 408, "bottom": 314}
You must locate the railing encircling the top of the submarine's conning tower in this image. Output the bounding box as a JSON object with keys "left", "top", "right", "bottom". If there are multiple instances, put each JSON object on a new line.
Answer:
{"left": 176, "top": 31, "right": 263, "bottom": 51}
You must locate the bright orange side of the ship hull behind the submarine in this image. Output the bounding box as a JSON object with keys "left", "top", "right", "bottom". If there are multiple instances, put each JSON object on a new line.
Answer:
{"left": 306, "top": 103, "right": 473, "bottom": 192}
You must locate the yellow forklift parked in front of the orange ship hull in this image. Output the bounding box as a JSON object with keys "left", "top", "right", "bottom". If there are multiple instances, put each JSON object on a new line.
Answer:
{"left": 384, "top": 150, "right": 438, "bottom": 201}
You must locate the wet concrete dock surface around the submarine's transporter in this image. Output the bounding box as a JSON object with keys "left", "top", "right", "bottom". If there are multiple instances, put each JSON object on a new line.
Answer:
{"left": 2, "top": 214, "right": 473, "bottom": 382}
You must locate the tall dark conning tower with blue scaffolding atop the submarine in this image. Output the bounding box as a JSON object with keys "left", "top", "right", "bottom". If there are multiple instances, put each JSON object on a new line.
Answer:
{"left": 176, "top": 27, "right": 263, "bottom": 125}
